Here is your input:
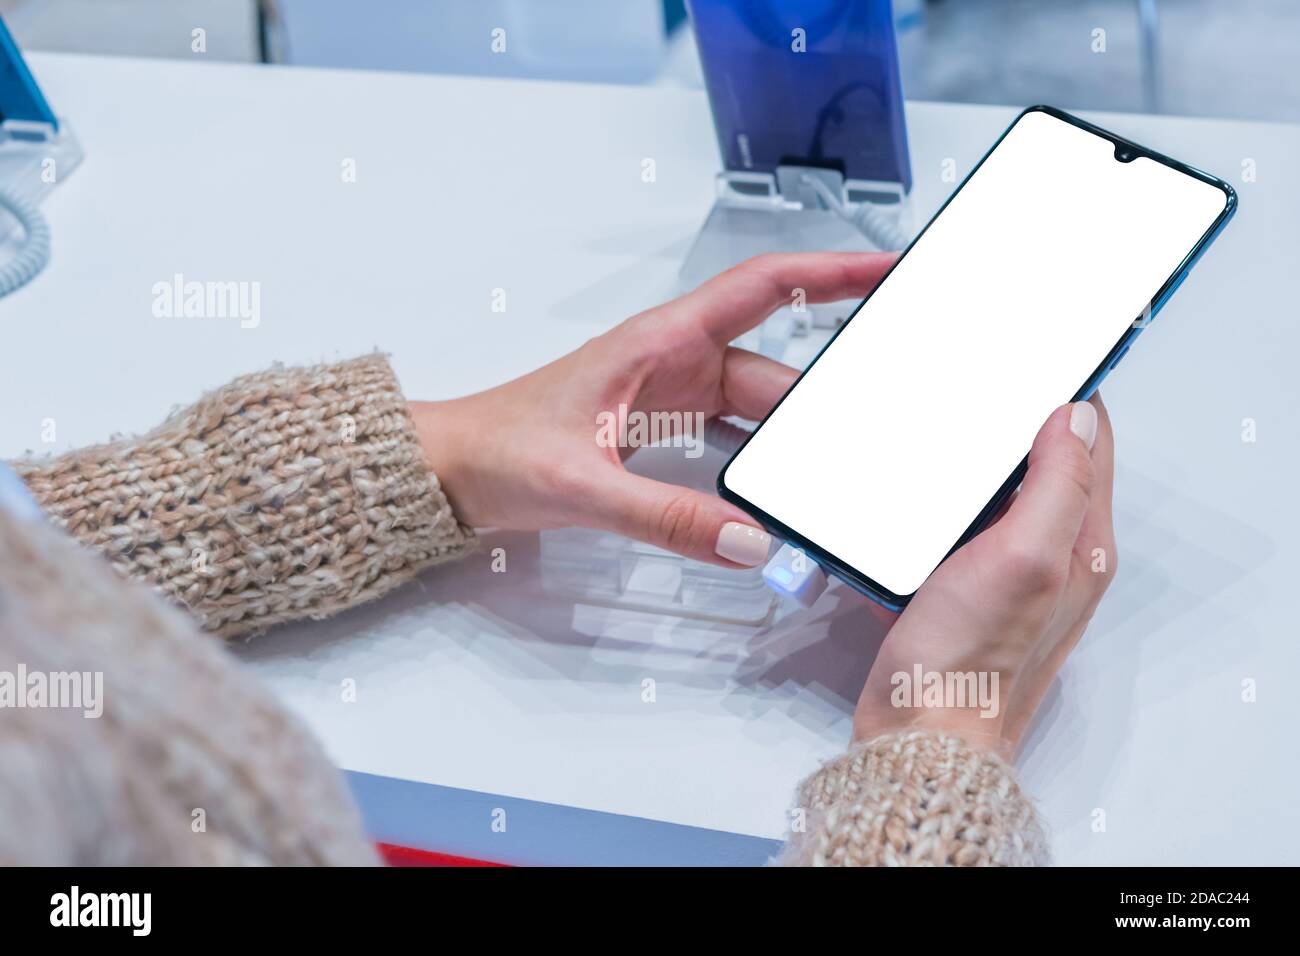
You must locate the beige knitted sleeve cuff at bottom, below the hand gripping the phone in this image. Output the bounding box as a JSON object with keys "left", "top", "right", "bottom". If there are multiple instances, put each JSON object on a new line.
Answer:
{"left": 779, "top": 731, "right": 1048, "bottom": 866}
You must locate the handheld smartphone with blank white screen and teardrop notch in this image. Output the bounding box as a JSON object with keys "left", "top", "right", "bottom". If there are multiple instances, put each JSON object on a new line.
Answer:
{"left": 718, "top": 107, "right": 1236, "bottom": 610}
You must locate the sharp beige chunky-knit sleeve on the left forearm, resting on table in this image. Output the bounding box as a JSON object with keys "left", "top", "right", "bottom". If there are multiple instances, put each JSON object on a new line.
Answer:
{"left": 14, "top": 355, "right": 473, "bottom": 637}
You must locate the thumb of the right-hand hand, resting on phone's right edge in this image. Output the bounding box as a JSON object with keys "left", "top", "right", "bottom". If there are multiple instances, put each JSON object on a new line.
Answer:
{"left": 998, "top": 402, "right": 1097, "bottom": 559}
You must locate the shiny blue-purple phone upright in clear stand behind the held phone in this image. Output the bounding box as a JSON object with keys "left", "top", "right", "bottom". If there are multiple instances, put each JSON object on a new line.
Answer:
{"left": 688, "top": 0, "right": 911, "bottom": 191}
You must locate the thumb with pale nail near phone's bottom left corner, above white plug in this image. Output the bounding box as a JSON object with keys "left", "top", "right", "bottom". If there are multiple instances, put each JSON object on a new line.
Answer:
{"left": 592, "top": 471, "right": 772, "bottom": 567}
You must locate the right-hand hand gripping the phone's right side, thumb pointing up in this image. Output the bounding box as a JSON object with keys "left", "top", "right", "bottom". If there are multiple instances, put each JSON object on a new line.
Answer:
{"left": 853, "top": 395, "right": 1115, "bottom": 757}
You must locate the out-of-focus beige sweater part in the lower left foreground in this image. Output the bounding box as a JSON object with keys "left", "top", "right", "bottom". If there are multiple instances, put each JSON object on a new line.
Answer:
{"left": 0, "top": 506, "right": 378, "bottom": 866}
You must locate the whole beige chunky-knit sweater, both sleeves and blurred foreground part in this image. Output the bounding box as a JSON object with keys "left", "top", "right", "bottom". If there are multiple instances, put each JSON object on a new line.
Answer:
{"left": 0, "top": 356, "right": 1045, "bottom": 865}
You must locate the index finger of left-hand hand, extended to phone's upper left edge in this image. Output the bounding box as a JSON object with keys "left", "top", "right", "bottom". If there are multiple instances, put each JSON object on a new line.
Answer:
{"left": 677, "top": 252, "right": 898, "bottom": 343}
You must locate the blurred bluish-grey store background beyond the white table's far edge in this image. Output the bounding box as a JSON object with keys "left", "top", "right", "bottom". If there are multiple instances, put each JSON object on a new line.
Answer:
{"left": 0, "top": 0, "right": 1300, "bottom": 121}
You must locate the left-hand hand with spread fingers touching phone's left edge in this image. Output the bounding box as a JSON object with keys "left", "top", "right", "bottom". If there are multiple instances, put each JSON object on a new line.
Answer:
{"left": 411, "top": 252, "right": 894, "bottom": 567}
